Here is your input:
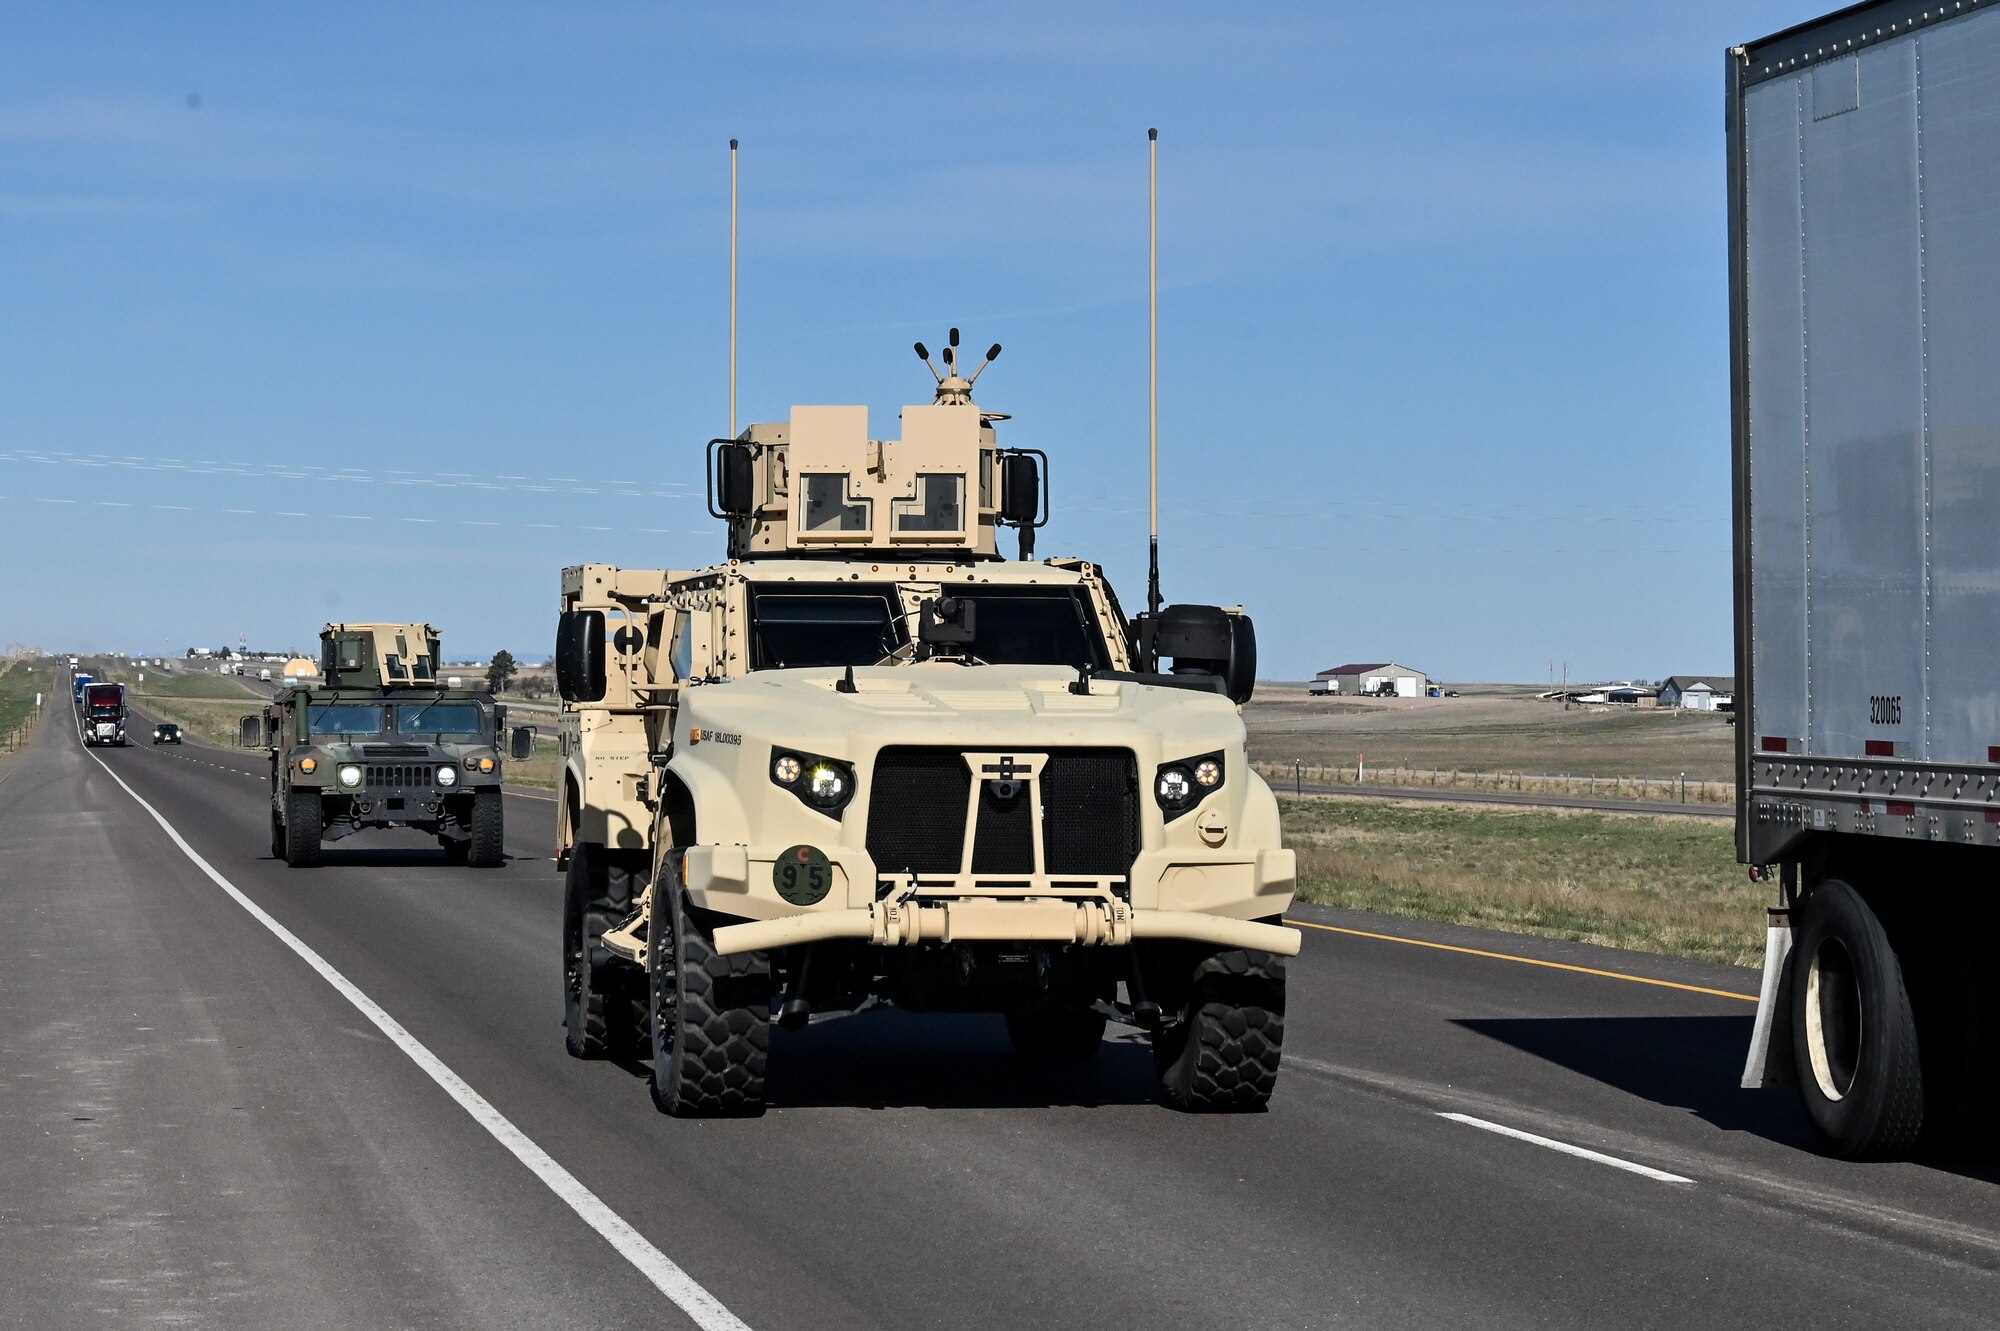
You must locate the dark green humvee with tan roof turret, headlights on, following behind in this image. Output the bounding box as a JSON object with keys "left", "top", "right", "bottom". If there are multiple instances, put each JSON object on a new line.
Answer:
{"left": 240, "top": 624, "right": 534, "bottom": 869}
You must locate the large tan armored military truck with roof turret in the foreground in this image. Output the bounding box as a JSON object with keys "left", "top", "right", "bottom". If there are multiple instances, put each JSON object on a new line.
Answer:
{"left": 556, "top": 330, "right": 1298, "bottom": 1115}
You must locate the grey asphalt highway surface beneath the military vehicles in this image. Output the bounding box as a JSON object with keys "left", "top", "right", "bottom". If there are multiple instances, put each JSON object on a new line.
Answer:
{"left": 0, "top": 687, "right": 2000, "bottom": 1331}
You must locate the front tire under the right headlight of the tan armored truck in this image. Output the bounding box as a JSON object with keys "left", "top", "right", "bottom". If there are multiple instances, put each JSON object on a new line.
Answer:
{"left": 1152, "top": 949, "right": 1284, "bottom": 1113}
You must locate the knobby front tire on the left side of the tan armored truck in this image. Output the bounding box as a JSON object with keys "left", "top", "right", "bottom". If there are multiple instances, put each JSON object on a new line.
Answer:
{"left": 646, "top": 875, "right": 772, "bottom": 1119}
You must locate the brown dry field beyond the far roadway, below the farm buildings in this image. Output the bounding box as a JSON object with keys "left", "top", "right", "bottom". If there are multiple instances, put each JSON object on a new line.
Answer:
{"left": 1244, "top": 683, "right": 1736, "bottom": 781}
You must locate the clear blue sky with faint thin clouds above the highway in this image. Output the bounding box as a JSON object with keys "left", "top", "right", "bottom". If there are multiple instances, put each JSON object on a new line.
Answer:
{"left": 0, "top": 0, "right": 1826, "bottom": 679}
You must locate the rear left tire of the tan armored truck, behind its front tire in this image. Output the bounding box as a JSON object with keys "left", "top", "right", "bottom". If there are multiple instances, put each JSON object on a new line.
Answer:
{"left": 562, "top": 841, "right": 646, "bottom": 1059}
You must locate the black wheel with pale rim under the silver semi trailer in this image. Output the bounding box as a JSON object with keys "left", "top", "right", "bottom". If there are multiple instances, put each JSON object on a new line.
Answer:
{"left": 1790, "top": 877, "right": 1924, "bottom": 1159}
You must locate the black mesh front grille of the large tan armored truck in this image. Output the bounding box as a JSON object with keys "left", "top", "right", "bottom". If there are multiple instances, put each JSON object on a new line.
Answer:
{"left": 868, "top": 745, "right": 1140, "bottom": 877}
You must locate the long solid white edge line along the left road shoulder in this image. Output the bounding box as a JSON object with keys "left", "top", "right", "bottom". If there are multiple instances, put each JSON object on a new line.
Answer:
{"left": 84, "top": 747, "right": 750, "bottom": 1331}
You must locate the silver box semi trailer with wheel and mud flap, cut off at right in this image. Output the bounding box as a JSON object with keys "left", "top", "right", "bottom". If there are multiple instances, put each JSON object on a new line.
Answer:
{"left": 1726, "top": 0, "right": 2000, "bottom": 1157}
